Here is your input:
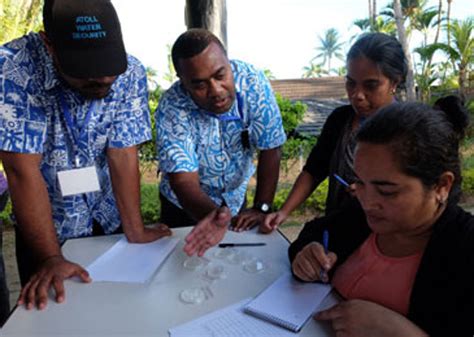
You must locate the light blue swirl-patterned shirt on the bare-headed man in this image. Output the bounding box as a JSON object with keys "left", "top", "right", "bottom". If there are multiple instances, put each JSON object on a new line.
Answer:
{"left": 155, "top": 60, "right": 286, "bottom": 215}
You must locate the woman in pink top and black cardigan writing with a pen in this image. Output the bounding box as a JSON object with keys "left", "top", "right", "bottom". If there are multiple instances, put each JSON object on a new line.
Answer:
{"left": 289, "top": 100, "right": 474, "bottom": 336}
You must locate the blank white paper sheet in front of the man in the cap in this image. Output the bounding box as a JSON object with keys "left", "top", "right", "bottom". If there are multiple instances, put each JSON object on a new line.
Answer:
{"left": 87, "top": 237, "right": 179, "bottom": 283}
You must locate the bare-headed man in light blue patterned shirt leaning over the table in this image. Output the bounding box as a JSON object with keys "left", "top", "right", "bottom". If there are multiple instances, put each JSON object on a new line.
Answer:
{"left": 156, "top": 29, "right": 286, "bottom": 231}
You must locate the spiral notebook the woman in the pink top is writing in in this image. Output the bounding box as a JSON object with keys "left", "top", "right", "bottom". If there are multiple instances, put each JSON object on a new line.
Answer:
{"left": 244, "top": 273, "right": 332, "bottom": 332}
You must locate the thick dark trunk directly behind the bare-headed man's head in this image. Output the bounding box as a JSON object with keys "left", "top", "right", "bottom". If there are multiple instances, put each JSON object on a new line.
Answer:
{"left": 185, "top": 0, "right": 227, "bottom": 49}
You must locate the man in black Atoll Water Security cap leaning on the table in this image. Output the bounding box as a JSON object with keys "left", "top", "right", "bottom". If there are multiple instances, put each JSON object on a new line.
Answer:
{"left": 0, "top": 0, "right": 170, "bottom": 309}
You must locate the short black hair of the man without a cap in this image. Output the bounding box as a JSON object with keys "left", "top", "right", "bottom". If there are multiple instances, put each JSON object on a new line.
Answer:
{"left": 171, "top": 28, "right": 227, "bottom": 75}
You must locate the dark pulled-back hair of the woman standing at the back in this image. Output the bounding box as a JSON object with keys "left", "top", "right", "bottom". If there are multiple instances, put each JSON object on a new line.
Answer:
{"left": 346, "top": 33, "right": 408, "bottom": 88}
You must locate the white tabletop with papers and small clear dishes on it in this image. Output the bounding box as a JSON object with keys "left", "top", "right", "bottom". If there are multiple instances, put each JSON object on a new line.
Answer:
{"left": 1, "top": 227, "right": 336, "bottom": 337}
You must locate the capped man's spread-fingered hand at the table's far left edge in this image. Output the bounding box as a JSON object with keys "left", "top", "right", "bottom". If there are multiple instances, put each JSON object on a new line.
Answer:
{"left": 18, "top": 255, "right": 92, "bottom": 310}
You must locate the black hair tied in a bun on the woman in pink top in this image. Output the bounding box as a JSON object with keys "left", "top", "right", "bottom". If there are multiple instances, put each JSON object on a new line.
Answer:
{"left": 357, "top": 102, "right": 469, "bottom": 203}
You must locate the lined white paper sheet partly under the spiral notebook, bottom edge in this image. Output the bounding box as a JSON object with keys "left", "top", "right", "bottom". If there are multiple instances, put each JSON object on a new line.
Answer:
{"left": 169, "top": 298, "right": 295, "bottom": 337}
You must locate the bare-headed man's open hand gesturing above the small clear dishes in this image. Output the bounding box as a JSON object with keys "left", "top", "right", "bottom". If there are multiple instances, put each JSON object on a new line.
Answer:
{"left": 184, "top": 206, "right": 232, "bottom": 256}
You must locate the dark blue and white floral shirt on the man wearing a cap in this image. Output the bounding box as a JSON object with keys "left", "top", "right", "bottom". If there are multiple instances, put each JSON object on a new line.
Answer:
{"left": 0, "top": 33, "right": 151, "bottom": 242}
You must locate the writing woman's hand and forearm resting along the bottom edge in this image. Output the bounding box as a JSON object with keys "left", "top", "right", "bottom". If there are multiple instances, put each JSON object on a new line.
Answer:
{"left": 314, "top": 300, "right": 428, "bottom": 337}
